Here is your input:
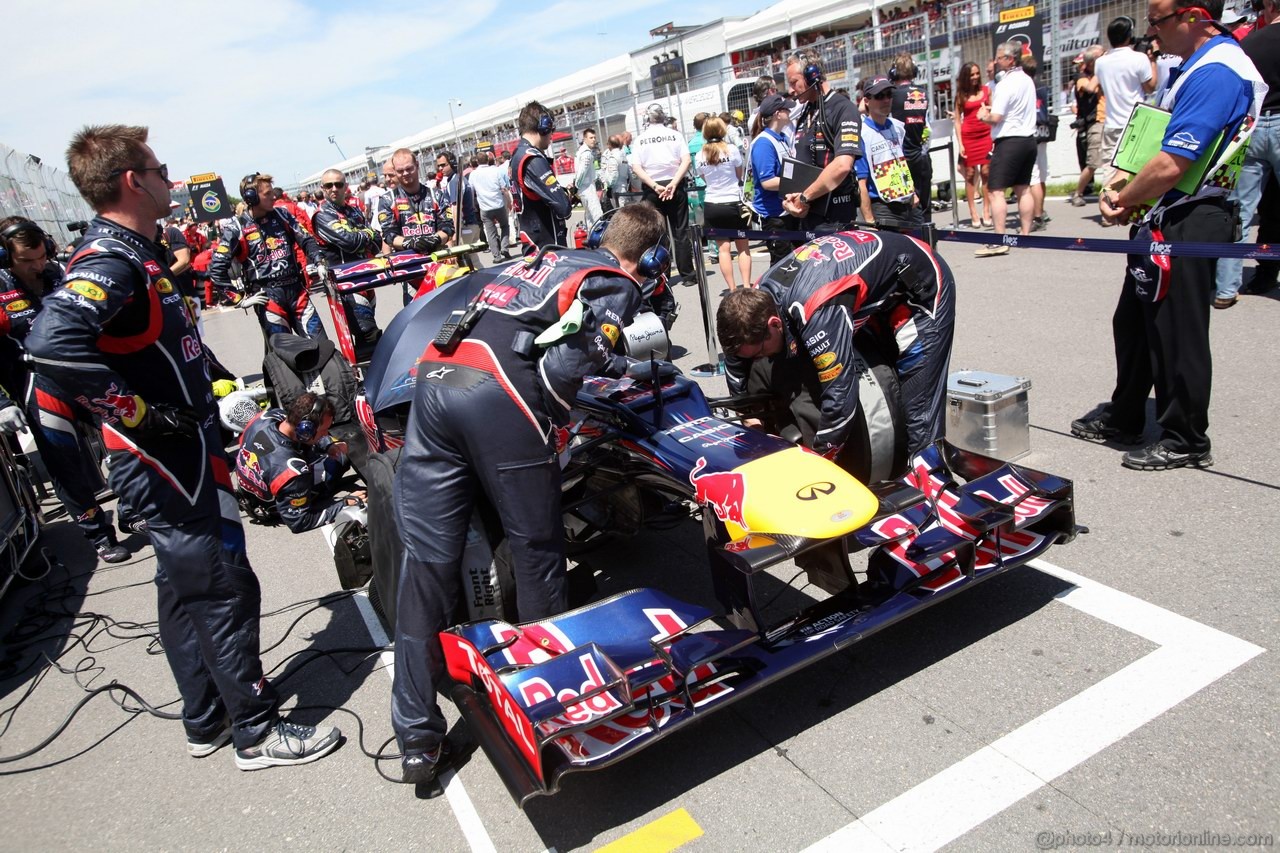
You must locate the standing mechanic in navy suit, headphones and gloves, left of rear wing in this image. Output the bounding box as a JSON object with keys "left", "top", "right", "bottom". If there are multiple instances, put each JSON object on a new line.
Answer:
{"left": 209, "top": 172, "right": 325, "bottom": 341}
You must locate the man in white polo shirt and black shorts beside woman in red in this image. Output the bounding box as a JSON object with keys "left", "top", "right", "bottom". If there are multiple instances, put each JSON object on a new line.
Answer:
{"left": 974, "top": 41, "right": 1037, "bottom": 257}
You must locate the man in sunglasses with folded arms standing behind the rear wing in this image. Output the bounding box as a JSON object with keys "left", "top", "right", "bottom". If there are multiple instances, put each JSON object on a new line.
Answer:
{"left": 311, "top": 169, "right": 383, "bottom": 347}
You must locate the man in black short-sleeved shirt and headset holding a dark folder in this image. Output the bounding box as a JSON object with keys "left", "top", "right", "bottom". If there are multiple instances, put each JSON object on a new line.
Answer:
{"left": 782, "top": 51, "right": 863, "bottom": 232}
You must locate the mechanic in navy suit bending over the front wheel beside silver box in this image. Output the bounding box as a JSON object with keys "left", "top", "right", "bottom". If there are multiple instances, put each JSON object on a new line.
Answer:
{"left": 716, "top": 231, "right": 955, "bottom": 482}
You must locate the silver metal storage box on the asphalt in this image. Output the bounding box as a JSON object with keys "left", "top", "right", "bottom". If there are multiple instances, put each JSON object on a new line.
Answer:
{"left": 947, "top": 370, "right": 1032, "bottom": 462}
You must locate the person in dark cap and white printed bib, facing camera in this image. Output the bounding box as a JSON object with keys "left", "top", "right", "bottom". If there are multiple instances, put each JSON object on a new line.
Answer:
{"left": 854, "top": 77, "right": 920, "bottom": 231}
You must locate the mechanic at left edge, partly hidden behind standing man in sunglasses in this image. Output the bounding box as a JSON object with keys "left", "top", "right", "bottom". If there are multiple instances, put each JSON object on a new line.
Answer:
{"left": 0, "top": 216, "right": 129, "bottom": 562}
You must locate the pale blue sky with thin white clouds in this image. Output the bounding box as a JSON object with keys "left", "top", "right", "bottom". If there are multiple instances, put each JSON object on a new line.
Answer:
{"left": 0, "top": 0, "right": 737, "bottom": 184}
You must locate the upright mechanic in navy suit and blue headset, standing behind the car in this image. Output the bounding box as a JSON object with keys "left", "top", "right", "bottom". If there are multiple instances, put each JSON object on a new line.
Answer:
{"left": 507, "top": 101, "right": 570, "bottom": 252}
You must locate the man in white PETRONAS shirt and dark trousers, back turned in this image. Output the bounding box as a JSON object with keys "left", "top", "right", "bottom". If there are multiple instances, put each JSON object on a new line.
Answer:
{"left": 630, "top": 104, "right": 694, "bottom": 282}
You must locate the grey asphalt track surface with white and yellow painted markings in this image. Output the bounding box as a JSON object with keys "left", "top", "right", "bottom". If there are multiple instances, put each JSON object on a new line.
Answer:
{"left": 0, "top": 200, "right": 1280, "bottom": 852}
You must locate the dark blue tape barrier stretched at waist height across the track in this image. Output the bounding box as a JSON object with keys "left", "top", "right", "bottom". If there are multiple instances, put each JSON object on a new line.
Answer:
{"left": 703, "top": 228, "right": 1280, "bottom": 260}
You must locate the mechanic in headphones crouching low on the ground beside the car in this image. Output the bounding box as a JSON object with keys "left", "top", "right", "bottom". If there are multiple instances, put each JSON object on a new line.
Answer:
{"left": 236, "top": 391, "right": 365, "bottom": 533}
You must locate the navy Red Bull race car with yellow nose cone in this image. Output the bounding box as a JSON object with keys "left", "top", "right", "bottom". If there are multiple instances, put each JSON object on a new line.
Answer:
{"left": 350, "top": 266, "right": 1079, "bottom": 804}
